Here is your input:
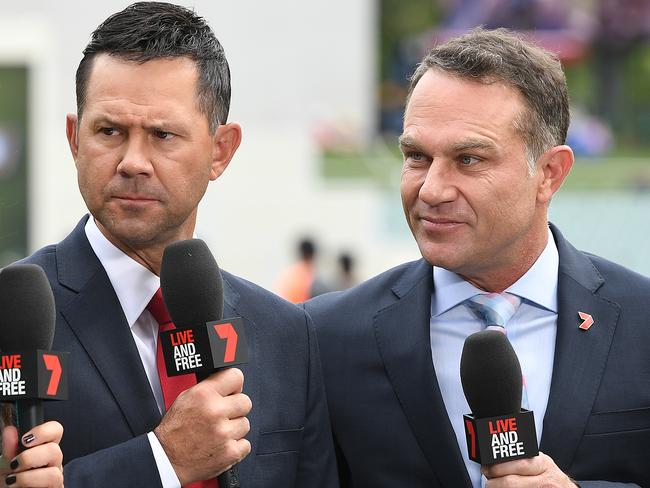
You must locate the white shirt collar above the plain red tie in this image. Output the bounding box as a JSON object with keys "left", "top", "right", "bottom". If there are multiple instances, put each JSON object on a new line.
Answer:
{"left": 85, "top": 216, "right": 160, "bottom": 327}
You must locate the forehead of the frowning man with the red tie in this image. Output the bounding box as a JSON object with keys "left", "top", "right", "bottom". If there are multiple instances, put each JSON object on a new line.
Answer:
{"left": 85, "top": 54, "right": 198, "bottom": 117}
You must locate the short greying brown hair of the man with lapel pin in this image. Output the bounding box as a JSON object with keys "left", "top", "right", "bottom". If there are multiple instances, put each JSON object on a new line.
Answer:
{"left": 407, "top": 27, "right": 569, "bottom": 171}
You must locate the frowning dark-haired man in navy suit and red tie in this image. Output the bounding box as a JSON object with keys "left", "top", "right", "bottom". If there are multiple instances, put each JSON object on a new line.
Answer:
{"left": 20, "top": 2, "right": 338, "bottom": 488}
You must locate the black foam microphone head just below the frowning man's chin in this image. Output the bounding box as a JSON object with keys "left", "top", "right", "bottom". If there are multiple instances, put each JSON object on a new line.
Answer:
{"left": 160, "top": 239, "right": 223, "bottom": 328}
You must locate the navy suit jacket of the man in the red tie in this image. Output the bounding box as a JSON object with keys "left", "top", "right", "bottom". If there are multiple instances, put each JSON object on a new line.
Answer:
{"left": 24, "top": 217, "right": 338, "bottom": 488}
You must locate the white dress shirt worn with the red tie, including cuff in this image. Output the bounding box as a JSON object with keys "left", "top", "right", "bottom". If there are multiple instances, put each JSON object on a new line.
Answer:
{"left": 85, "top": 216, "right": 181, "bottom": 488}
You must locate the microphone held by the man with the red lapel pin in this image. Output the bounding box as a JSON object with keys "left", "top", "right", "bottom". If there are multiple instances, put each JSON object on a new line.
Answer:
{"left": 460, "top": 330, "right": 539, "bottom": 465}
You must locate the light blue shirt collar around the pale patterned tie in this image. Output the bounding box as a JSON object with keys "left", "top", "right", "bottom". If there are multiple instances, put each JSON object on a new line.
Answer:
{"left": 432, "top": 229, "right": 560, "bottom": 316}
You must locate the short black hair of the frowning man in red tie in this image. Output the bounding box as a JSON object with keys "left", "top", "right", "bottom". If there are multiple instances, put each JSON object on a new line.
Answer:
{"left": 76, "top": 2, "right": 230, "bottom": 132}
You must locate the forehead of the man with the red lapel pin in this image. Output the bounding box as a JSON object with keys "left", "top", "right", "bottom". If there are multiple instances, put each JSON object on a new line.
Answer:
{"left": 404, "top": 69, "right": 525, "bottom": 143}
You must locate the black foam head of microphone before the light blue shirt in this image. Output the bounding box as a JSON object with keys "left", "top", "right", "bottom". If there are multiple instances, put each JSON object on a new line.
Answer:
{"left": 460, "top": 330, "right": 522, "bottom": 419}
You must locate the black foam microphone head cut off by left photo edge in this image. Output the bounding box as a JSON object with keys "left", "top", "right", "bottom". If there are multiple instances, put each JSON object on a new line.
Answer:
{"left": 0, "top": 264, "right": 56, "bottom": 351}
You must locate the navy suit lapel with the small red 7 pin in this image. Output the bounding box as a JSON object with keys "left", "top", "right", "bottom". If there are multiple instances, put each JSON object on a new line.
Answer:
{"left": 540, "top": 227, "right": 620, "bottom": 470}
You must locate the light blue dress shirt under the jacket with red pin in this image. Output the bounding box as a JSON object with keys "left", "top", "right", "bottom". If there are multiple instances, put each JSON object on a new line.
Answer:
{"left": 430, "top": 230, "right": 559, "bottom": 488}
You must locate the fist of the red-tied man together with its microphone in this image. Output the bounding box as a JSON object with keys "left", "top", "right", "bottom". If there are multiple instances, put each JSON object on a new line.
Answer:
{"left": 154, "top": 239, "right": 252, "bottom": 488}
